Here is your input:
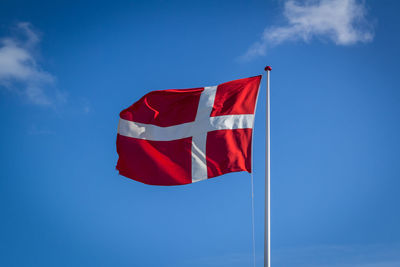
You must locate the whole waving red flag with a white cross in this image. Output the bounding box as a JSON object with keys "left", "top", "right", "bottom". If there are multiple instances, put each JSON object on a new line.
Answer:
{"left": 117, "top": 75, "right": 261, "bottom": 185}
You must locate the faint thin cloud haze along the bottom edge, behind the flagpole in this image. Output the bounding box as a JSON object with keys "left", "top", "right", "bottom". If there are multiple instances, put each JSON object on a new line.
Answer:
{"left": 176, "top": 244, "right": 400, "bottom": 267}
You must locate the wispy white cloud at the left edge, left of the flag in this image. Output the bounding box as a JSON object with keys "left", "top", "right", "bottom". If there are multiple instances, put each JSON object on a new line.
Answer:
{"left": 0, "top": 22, "right": 66, "bottom": 106}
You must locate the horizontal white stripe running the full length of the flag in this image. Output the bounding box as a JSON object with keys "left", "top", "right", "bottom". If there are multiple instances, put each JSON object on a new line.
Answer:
{"left": 118, "top": 114, "right": 254, "bottom": 141}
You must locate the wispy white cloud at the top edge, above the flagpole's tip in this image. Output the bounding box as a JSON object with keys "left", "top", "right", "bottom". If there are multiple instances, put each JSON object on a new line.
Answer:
{"left": 242, "top": 0, "right": 374, "bottom": 59}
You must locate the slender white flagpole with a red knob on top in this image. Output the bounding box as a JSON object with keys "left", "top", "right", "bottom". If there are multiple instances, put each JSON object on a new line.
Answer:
{"left": 264, "top": 66, "right": 272, "bottom": 267}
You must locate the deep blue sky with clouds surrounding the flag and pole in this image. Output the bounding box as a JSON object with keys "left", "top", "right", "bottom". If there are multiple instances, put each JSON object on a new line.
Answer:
{"left": 0, "top": 0, "right": 400, "bottom": 267}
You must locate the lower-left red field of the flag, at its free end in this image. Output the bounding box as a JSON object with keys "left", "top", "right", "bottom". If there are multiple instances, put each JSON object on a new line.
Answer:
{"left": 117, "top": 134, "right": 192, "bottom": 185}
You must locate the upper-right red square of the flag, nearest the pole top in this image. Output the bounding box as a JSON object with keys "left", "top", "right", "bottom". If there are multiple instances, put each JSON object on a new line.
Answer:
{"left": 211, "top": 75, "right": 261, "bottom": 117}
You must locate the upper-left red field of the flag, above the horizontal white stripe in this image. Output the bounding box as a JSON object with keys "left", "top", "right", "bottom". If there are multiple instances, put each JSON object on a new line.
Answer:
{"left": 120, "top": 88, "right": 204, "bottom": 127}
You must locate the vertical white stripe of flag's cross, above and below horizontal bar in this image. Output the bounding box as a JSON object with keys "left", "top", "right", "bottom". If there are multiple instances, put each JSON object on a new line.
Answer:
{"left": 192, "top": 86, "right": 217, "bottom": 183}
